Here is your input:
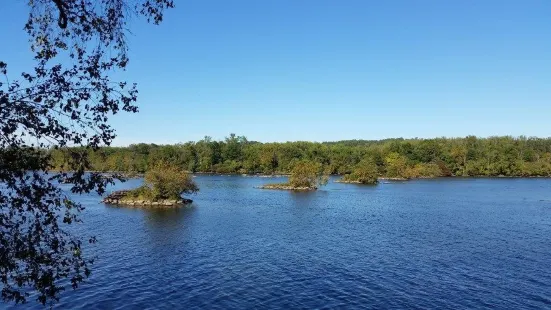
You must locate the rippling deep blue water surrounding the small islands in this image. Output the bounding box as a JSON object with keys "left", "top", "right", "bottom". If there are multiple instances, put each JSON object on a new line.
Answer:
{"left": 6, "top": 176, "right": 551, "bottom": 309}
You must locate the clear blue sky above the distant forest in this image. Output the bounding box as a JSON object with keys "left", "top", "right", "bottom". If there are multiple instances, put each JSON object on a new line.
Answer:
{"left": 0, "top": 0, "right": 551, "bottom": 145}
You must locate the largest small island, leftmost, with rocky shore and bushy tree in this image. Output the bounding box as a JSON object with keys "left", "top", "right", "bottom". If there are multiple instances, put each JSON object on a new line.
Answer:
{"left": 102, "top": 162, "right": 199, "bottom": 207}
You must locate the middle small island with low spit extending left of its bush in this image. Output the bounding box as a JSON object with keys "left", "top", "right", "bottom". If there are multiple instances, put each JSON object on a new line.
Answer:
{"left": 259, "top": 160, "right": 329, "bottom": 191}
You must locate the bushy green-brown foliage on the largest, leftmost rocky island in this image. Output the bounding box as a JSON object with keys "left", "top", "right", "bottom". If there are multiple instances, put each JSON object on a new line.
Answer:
{"left": 143, "top": 162, "right": 199, "bottom": 201}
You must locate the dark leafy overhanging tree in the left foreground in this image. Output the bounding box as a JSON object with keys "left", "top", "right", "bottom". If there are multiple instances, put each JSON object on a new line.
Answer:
{"left": 0, "top": 0, "right": 173, "bottom": 304}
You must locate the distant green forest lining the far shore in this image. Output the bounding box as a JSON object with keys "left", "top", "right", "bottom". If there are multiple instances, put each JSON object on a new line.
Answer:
{"left": 50, "top": 134, "right": 551, "bottom": 178}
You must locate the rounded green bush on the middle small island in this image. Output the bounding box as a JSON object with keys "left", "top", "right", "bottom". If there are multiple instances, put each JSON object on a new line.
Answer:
{"left": 289, "top": 160, "right": 329, "bottom": 188}
